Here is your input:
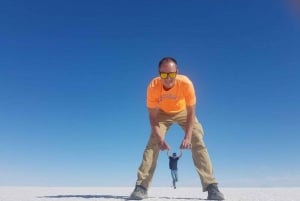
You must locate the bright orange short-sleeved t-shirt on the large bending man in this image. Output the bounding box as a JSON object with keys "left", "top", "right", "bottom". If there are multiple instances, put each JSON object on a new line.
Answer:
{"left": 147, "top": 75, "right": 196, "bottom": 113}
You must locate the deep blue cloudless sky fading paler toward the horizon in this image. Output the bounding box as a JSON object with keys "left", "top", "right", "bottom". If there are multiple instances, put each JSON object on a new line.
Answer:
{"left": 0, "top": 0, "right": 300, "bottom": 186}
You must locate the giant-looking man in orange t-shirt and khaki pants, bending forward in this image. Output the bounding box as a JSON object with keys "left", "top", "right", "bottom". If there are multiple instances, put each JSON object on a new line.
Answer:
{"left": 129, "top": 57, "right": 224, "bottom": 200}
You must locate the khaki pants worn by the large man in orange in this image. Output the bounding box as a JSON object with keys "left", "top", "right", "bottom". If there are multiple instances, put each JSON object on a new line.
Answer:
{"left": 136, "top": 110, "right": 217, "bottom": 191}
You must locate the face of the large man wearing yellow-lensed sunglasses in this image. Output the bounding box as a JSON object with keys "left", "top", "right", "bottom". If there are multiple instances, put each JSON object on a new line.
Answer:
{"left": 159, "top": 61, "right": 177, "bottom": 89}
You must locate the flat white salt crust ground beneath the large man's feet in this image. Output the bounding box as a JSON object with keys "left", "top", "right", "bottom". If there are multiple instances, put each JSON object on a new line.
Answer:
{"left": 0, "top": 187, "right": 300, "bottom": 201}
